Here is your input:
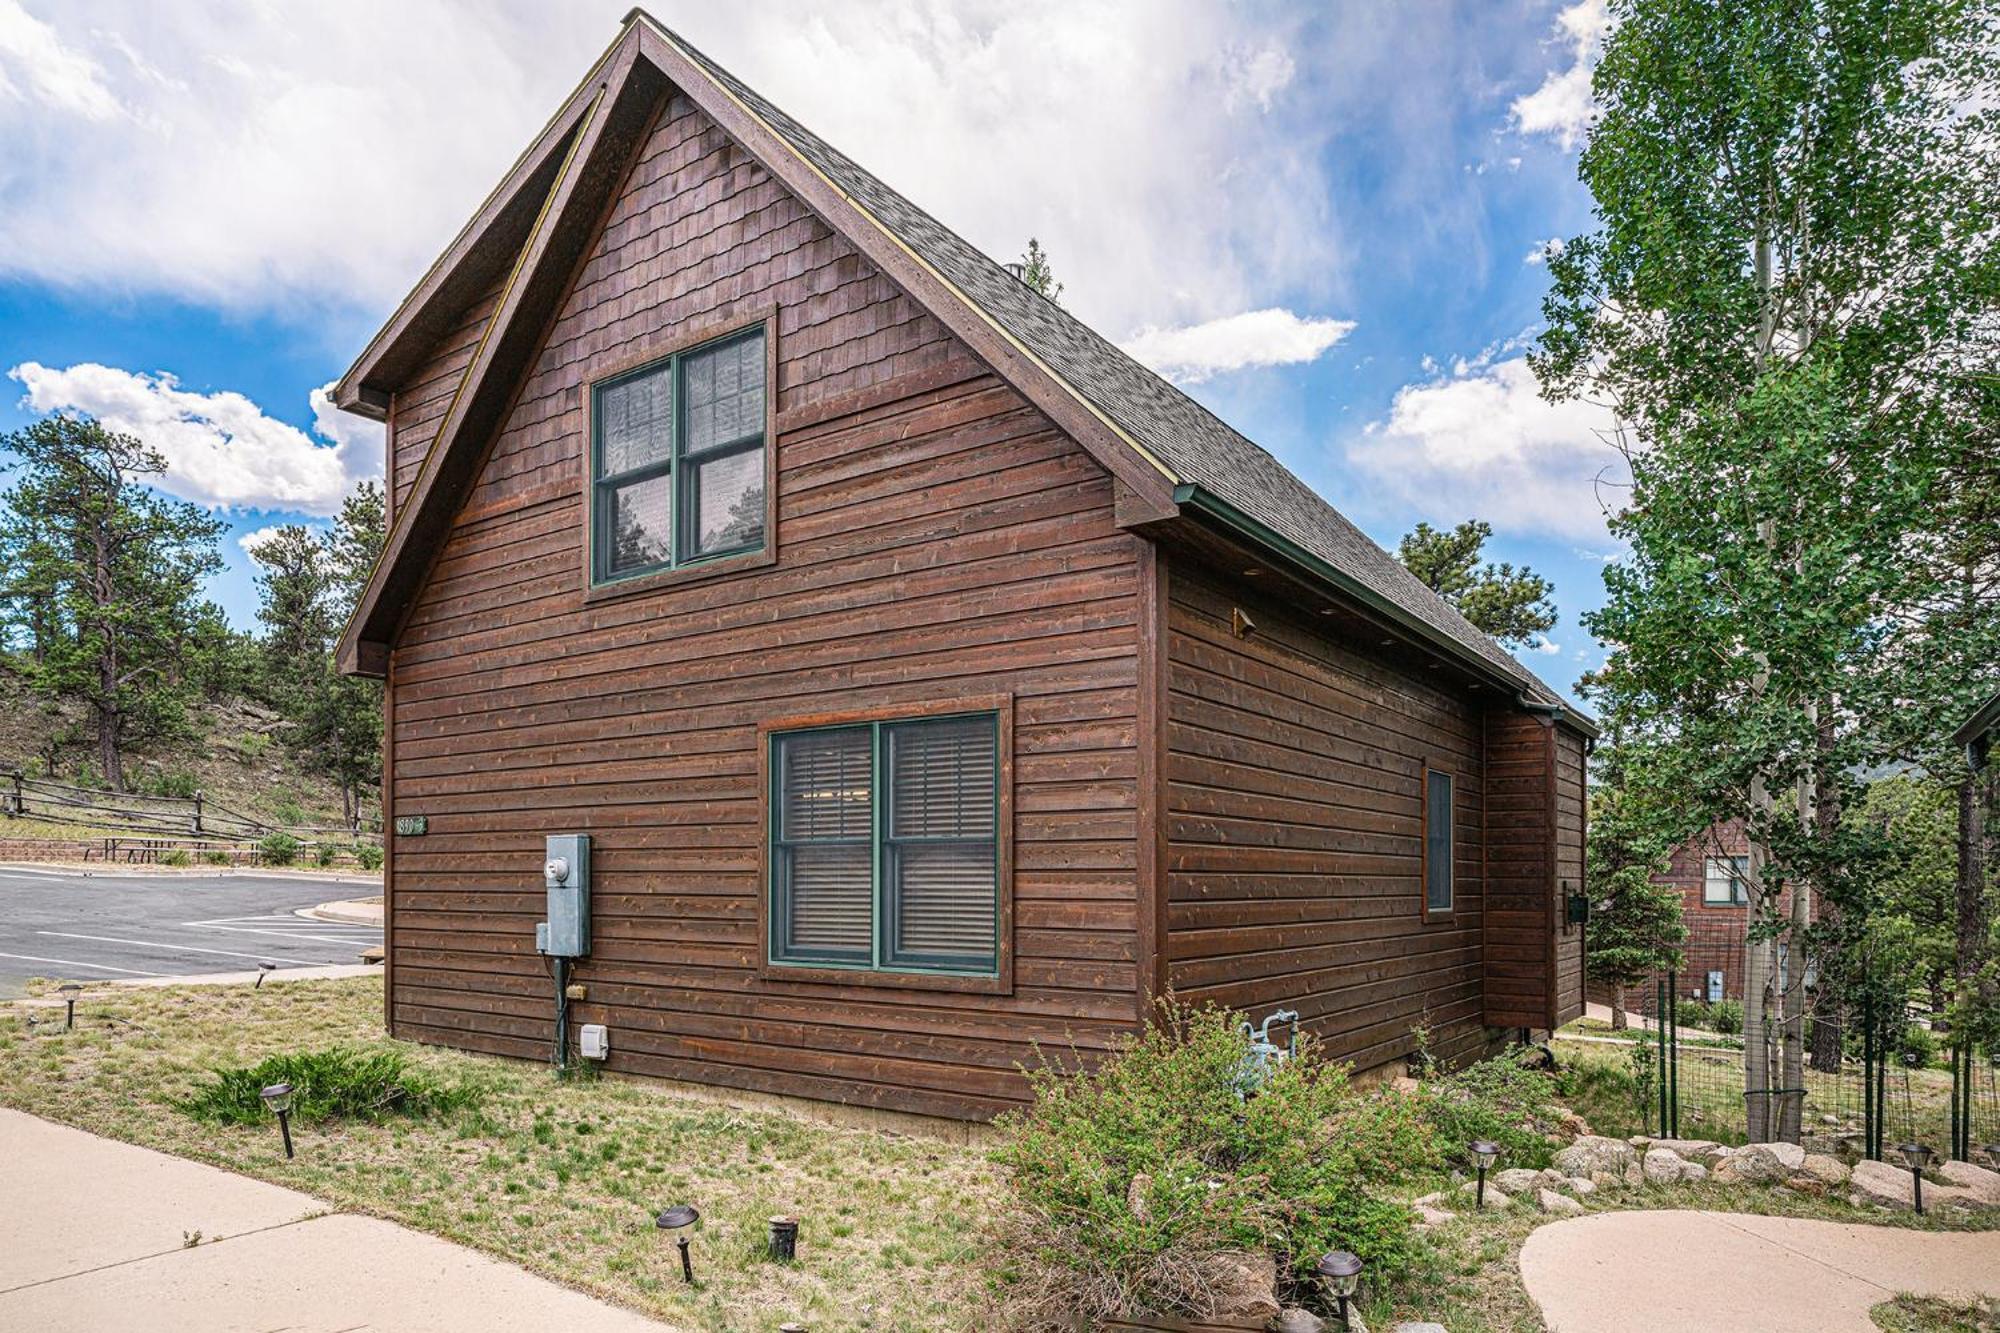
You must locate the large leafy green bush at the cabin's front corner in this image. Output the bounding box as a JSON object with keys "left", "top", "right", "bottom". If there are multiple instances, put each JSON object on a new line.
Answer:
{"left": 994, "top": 1005, "right": 1440, "bottom": 1331}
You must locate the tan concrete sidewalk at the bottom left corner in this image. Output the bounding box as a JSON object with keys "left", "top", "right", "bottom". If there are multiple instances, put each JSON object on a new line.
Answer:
{"left": 0, "top": 1109, "right": 664, "bottom": 1333}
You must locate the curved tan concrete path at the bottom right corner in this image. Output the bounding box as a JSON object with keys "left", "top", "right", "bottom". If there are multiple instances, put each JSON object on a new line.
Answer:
{"left": 1520, "top": 1211, "right": 2000, "bottom": 1333}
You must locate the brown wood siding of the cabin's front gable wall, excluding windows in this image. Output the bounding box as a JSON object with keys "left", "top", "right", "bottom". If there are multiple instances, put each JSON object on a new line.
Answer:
{"left": 392, "top": 88, "right": 1138, "bottom": 1117}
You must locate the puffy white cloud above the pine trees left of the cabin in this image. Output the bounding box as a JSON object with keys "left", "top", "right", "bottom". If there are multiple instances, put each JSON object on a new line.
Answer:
{"left": 8, "top": 360, "right": 382, "bottom": 514}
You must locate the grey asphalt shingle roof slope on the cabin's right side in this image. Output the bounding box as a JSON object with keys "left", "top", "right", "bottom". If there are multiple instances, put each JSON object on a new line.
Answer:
{"left": 656, "top": 24, "right": 1562, "bottom": 707}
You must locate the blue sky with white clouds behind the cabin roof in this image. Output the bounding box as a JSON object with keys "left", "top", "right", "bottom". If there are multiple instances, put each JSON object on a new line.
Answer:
{"left": 0, "top": 0, "right": 1618, "bottom": 700}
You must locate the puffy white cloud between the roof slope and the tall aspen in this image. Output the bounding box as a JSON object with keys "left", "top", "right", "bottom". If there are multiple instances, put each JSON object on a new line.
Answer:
{"left": 1348, "top": 356, "right": 1624, "bottom": 542}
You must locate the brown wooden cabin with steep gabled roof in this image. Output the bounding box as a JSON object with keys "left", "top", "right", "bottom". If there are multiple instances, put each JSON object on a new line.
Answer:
{"left": 336, "top": 12, "right": 1592, "bottom": 1119}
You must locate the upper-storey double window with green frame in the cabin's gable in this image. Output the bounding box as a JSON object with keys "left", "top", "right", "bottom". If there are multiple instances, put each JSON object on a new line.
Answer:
{"left": 590, "top": 328, "right": 766, "bottom": 582}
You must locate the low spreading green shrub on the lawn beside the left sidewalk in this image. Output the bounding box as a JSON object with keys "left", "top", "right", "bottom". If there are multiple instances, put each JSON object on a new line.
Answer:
{"left": 174, "top": 1047, "right": 478, "bottom": 1125}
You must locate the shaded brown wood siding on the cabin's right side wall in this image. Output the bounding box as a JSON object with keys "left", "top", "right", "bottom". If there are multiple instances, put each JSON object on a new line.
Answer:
{"left": 1166, "top": 560, "right": 1486, "bottom": 1069}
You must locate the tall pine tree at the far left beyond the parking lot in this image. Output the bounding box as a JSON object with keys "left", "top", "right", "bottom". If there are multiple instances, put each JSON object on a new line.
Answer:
{"left": 0, "top": 416, "right": 224, "bottom": 789}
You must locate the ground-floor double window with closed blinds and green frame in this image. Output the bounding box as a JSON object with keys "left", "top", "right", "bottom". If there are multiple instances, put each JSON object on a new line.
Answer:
{"left": 770, "top": 713, "right": 1000, "bottom": 975}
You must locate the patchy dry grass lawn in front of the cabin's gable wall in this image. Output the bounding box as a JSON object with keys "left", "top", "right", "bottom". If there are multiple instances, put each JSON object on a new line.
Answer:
{"left": 0, "top": 977, "right": 996, "bottom": 1331}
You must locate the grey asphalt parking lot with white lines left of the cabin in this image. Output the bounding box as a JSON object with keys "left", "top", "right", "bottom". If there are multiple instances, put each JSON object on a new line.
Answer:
{"left": 0, "top": 865, "right": 382, "bottom": 997}
